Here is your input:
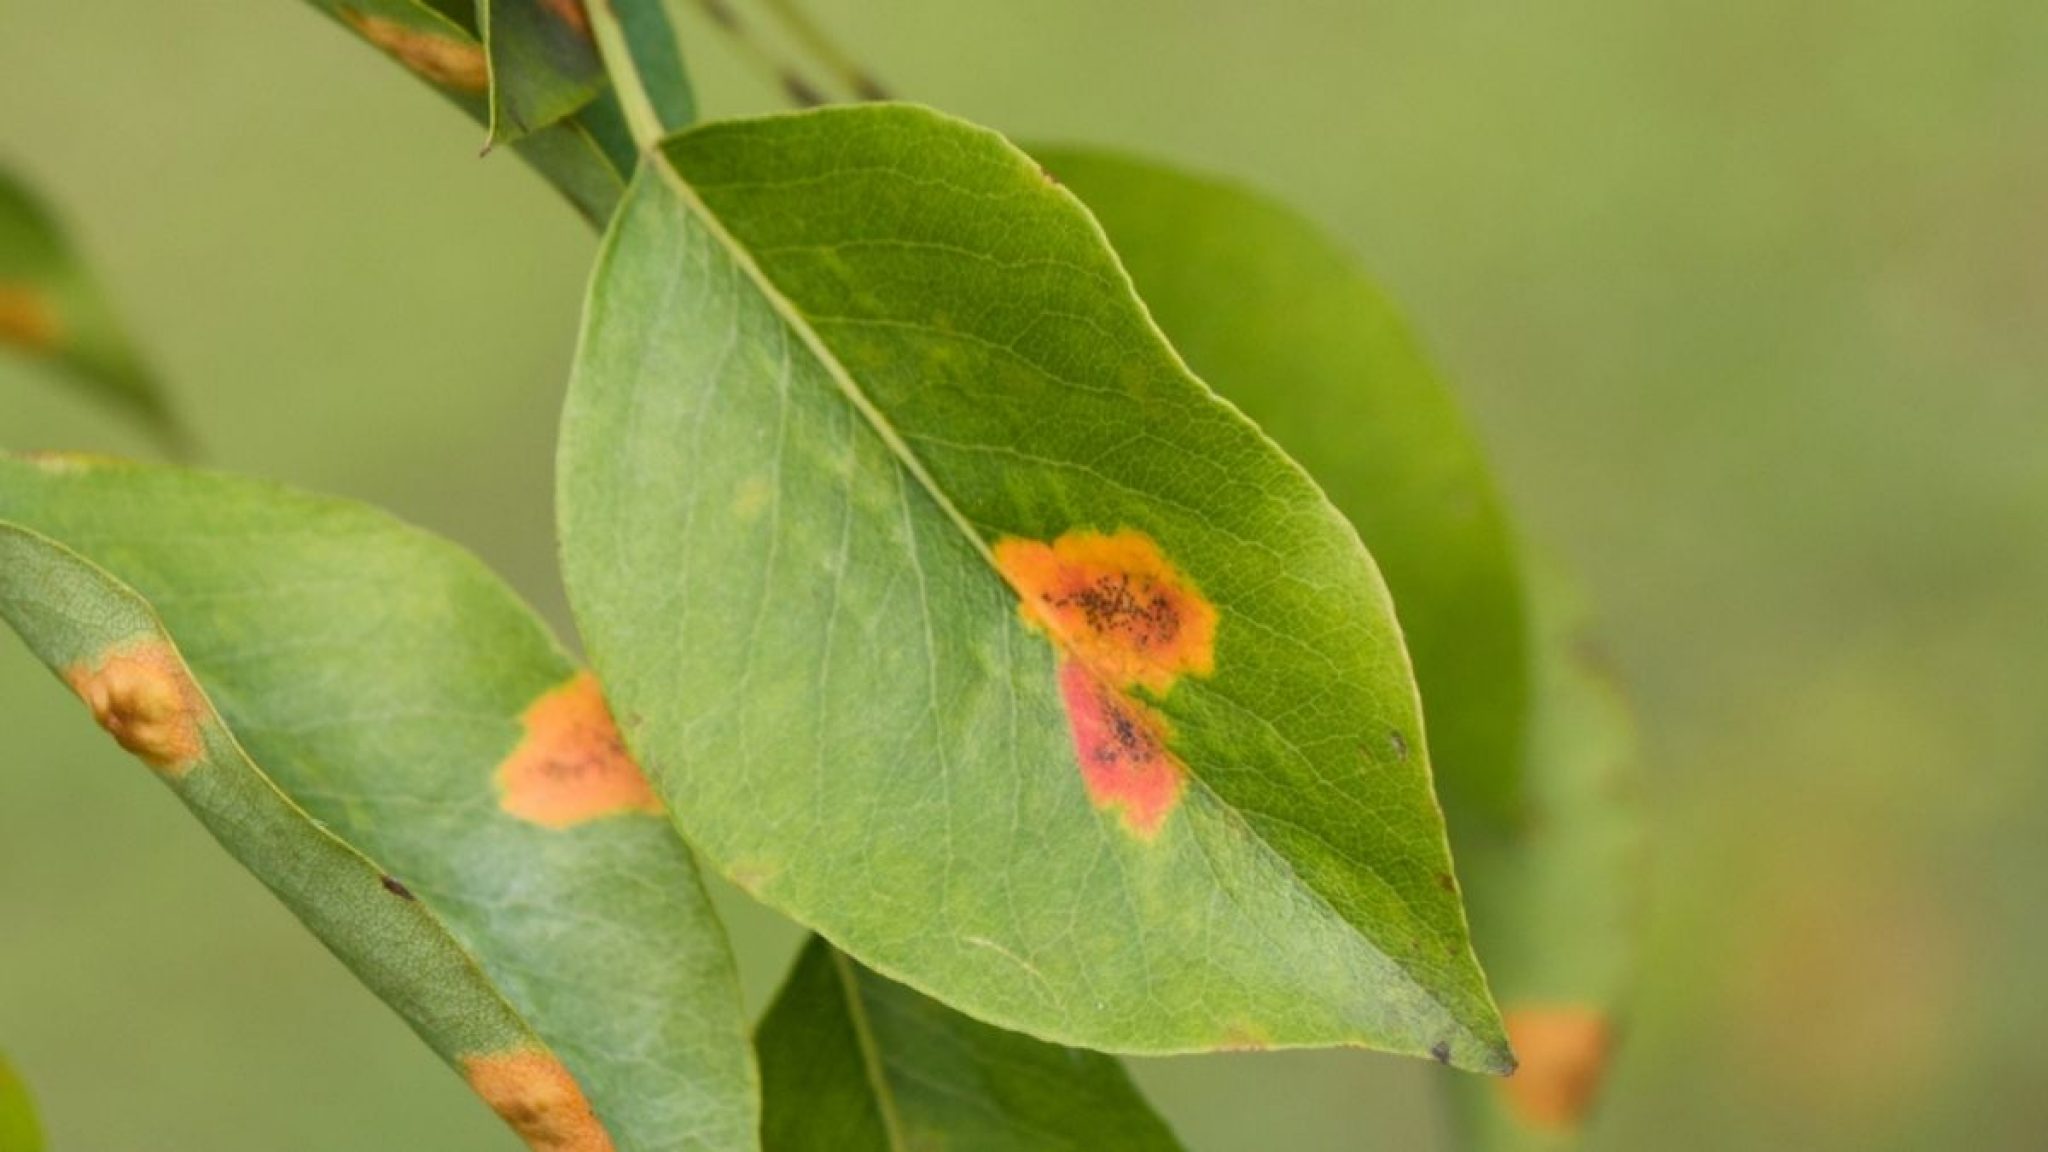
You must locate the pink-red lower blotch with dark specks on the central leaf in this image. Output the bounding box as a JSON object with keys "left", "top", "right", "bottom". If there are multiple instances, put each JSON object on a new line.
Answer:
{"left": 1059, "top": 660, "right": 1188, "bottom": 838}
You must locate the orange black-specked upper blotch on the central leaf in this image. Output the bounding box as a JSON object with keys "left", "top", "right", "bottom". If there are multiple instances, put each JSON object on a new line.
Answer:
{"left": 995, "top": 529, "right": 1217, "bottom": 695}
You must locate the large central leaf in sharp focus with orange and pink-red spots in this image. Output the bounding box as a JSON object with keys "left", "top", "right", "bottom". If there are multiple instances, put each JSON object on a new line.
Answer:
{"left": 559, "top": 105, "right": 1509, "bottom": 1070}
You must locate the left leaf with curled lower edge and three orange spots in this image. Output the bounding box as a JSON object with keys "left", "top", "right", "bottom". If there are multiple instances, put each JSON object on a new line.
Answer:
{"left": 0, "top": 457, "right": 756, "bottom": 1152}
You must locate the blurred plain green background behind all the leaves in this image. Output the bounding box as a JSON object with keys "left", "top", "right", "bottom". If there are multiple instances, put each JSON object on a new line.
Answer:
{"left": 0, "top": 0, "right": 2048, "bottom": 1152}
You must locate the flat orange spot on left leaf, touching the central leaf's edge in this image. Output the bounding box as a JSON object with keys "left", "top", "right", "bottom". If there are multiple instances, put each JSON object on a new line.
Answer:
{"left": 498, "top": 672, "right": 662, "bottom": 828}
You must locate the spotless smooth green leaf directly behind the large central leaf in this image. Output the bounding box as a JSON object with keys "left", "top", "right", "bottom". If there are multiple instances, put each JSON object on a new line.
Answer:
{"left": 1032, "top": 148, "right": 1528, "bottom": 826}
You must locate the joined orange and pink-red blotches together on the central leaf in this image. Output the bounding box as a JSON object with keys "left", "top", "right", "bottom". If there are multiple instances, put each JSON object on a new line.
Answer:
{"left": 995, "top": 529, "right": 1217, "bottom": 838}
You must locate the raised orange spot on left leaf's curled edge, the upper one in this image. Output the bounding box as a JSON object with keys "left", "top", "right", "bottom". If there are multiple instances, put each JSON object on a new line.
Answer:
{"left": 63, "top": 640, "right": 207, "bottom": 779}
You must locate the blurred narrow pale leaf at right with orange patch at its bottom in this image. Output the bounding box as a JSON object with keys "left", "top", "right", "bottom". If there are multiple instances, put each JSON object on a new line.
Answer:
{"left": 1452, "top": 592, "right": 1647, "bottom": 1150}
